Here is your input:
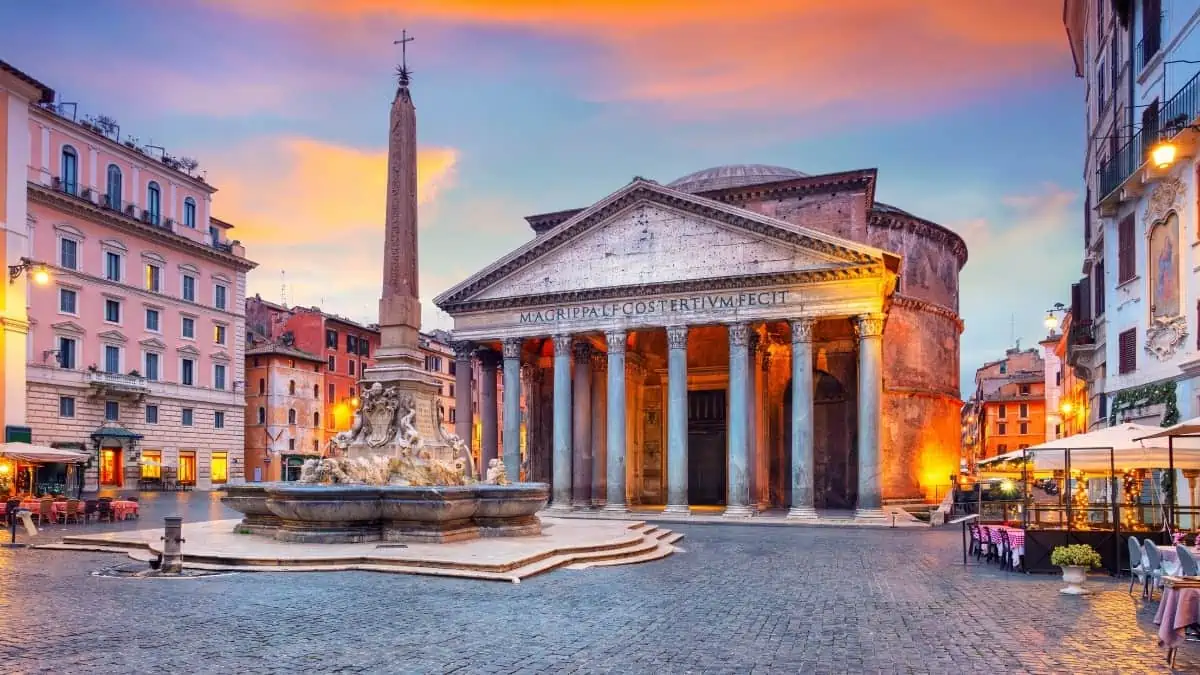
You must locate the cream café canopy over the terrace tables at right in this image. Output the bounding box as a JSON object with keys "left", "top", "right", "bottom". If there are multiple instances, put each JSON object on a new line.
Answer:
{"left": 979, "top": 423, "right": 1200, "bottom": 472}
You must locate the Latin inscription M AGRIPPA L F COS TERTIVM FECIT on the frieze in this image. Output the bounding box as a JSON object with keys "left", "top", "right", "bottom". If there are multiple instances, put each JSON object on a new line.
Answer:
{"left": 521, "top": 291, "right": 788, "bottom": 323}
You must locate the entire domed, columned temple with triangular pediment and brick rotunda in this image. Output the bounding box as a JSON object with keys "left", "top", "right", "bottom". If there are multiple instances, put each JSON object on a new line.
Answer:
{"left": 434, "top": 165, "right": 966, "bottom": 518}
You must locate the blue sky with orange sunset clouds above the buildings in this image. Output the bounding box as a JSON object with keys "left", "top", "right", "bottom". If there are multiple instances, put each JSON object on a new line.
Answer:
{"left": 0, "top": 0, "right": 1084, "bottom": 387}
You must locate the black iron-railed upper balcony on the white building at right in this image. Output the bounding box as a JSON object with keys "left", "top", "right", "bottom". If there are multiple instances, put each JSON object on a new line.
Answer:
{"left": 1099, "top": 73, "right": 1200, "bottom": 207}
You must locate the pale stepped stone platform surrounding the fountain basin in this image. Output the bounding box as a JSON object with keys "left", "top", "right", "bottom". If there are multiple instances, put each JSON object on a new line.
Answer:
{"left": 38, "top": 518, "right": 674, "bottom": 581}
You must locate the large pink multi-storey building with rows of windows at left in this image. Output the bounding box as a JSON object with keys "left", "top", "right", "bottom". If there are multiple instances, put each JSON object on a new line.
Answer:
{"left": 7, "top": 59, "right": 254, "bottom": 490}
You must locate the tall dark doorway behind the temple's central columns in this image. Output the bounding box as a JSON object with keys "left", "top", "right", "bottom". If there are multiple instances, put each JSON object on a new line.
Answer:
{"left": 688, "top": 389, "right": 727, "bottom": 506}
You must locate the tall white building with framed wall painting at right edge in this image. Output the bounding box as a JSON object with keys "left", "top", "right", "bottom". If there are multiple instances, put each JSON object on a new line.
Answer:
{"left": 1063, "top": 0, "right": 1200, "bottom": 426}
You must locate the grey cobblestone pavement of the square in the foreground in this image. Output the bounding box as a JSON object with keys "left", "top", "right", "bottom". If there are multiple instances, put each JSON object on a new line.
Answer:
{"left": 0, "top": 492, "right": 1185, "bottom": 674}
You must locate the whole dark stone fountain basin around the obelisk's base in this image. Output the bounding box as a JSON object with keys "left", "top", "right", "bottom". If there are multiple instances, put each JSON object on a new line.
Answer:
{"left": 236, "top": 482, "right": 550, "bottom": 544}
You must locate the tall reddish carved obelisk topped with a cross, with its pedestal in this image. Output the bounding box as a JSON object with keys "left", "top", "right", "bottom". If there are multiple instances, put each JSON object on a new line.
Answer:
{"left": 349, "top": 32, "right": 450, "bottom": 455}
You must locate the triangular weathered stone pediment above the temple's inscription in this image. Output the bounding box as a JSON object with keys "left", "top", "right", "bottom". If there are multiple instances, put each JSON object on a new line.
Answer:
{"left": 434, "top": 180, "right": 888, "bottom": 307}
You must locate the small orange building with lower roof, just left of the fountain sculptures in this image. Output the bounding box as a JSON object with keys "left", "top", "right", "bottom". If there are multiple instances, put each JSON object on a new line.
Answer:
{"left": 246, "top": 342, "right": 328, "bottom": 482}
